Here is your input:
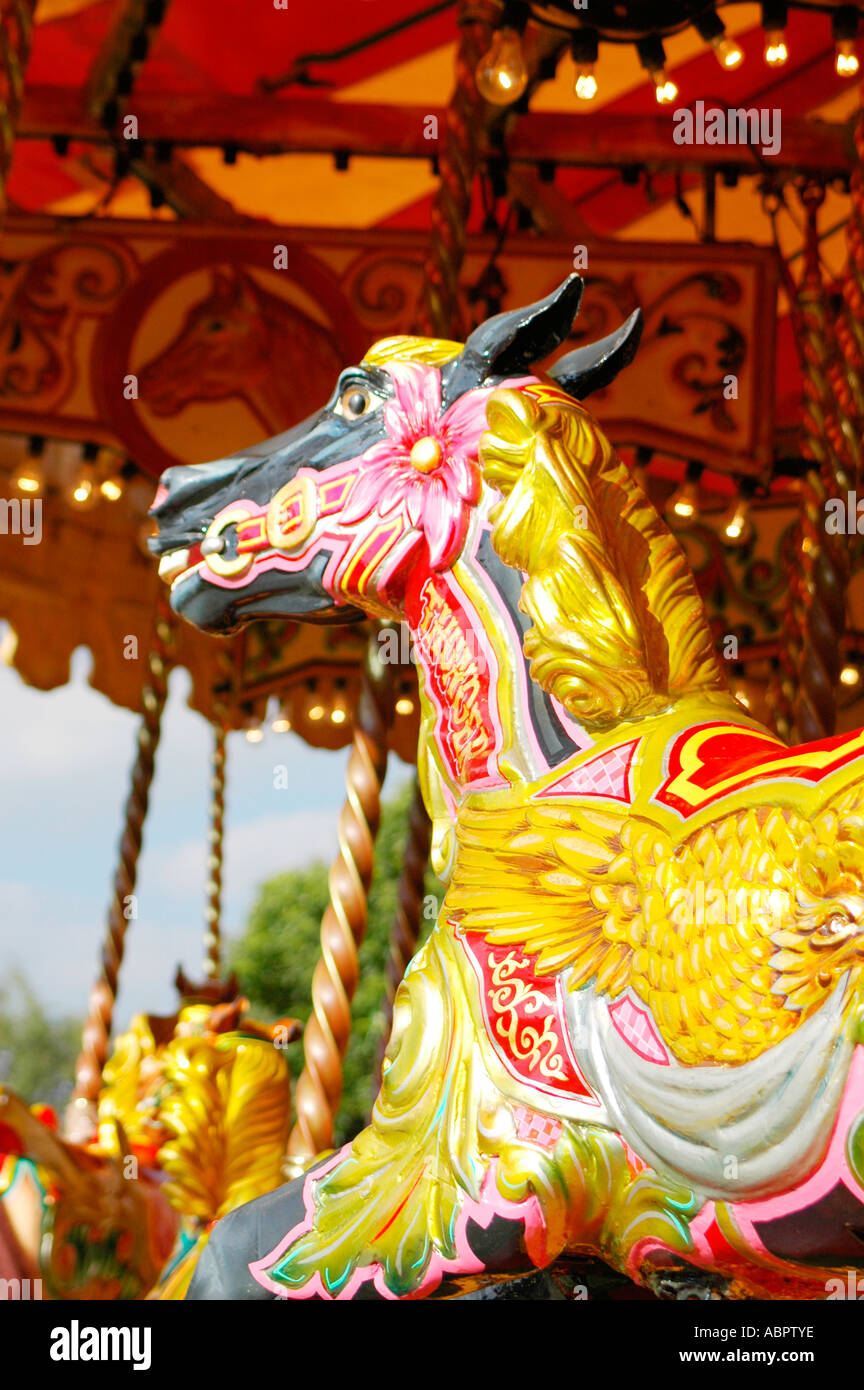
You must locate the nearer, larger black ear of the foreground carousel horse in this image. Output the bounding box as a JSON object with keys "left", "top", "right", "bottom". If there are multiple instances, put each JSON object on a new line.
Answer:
{"left": 446, "top": 275, "right": 583, "bottom": 400}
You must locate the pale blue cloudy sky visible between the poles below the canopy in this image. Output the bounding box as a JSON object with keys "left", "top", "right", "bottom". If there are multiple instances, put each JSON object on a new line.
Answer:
{"left": 0, "top": 651, "right": 408, "bottom": 1024}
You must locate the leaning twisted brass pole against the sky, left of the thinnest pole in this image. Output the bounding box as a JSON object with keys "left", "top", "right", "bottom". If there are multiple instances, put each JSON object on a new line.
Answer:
{"left": 65, "top": 595, "right": 171, "bottom": 1141}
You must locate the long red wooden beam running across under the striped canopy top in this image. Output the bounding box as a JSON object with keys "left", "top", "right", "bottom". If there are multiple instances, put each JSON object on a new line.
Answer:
{"left": 18, "top": 86, "right": 854, "bottom": 179}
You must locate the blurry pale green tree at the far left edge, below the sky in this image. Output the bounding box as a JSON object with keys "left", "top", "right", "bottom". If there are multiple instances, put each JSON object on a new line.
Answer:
{"left": 0, "top": 972, "right": 81, "bottom": 1108}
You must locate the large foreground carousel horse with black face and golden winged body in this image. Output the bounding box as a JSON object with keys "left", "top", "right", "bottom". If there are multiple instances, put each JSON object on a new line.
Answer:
{"left": 151, "top": 277, "right": 864, "bottom": 1298}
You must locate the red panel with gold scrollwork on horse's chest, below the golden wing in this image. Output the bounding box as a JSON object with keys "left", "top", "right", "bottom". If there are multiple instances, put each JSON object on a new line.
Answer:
{"left": 460, "top": 933, "right": 600, "bottom": 1105}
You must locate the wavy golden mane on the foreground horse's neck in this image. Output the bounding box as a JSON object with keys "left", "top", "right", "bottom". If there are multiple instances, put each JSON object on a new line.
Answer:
{"left": 479, "top": 389, "right": 725, "bottom": 727}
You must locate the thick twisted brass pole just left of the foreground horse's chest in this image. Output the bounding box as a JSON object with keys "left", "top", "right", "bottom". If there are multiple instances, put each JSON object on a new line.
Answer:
{"left": 286, "top": 637, "right": 390, "bottom": 1175}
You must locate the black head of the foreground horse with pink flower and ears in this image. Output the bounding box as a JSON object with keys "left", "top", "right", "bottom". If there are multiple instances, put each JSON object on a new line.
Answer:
{"left": 151, "top": 275, "right": 640, "bottom": 631}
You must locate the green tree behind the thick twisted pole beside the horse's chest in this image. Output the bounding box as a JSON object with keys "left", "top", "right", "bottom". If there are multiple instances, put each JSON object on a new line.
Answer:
{"left": 231, "top": 783, "right": 443, "bottom": 1144}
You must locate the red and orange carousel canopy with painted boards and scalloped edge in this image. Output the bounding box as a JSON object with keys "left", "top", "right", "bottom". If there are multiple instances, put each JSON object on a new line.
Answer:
{"left": 0, "top": 0, "right": 864, "bottom": 753}
